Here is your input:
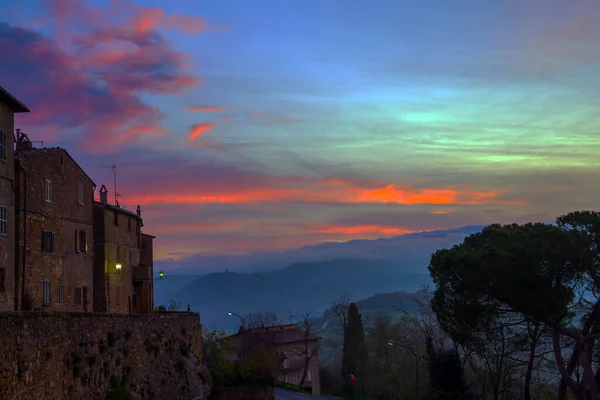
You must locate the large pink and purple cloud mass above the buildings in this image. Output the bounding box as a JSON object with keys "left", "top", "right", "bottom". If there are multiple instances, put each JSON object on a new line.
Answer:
{"left": 0, "top": 0, "right": 219, "bottom": 153}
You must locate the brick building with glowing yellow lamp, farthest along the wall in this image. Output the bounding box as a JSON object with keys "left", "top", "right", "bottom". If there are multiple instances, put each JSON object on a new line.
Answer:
{"left": 94, "top": 185, "right": 154, "bottom": 314}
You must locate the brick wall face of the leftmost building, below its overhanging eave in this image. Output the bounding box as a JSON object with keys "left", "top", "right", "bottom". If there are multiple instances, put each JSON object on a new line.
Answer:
{"left": 0, "top": 98, "right": 15, "bottom": 311}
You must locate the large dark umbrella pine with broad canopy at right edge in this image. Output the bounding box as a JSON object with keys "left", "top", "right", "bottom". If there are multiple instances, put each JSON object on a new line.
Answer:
{"left": 429, "top": 211, "right": 600, "bottom": 400}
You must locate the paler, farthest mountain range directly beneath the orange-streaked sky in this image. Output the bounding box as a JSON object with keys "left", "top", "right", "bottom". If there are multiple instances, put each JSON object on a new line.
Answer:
{"left": 155, "top": 226, "right": 483, "bottom": 275}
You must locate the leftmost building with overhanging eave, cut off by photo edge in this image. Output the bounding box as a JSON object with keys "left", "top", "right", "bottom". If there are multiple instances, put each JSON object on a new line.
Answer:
{"left": 0, "top": 86, "right": 29, "bottom": 311}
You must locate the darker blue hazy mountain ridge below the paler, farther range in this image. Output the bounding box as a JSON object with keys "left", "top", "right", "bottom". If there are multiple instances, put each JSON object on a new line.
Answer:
{"left": 163, "top": 259, "right": 431, "bottom": 329}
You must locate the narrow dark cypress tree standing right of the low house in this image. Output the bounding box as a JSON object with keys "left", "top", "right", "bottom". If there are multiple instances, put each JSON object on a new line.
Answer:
{"left": 342, "top": 303, "right": 369, "bottom": 391}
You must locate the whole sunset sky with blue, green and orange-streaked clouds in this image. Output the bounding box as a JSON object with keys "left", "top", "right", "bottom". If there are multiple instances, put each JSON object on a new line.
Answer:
{"left": 0, "top": 0, "right": 600, "bottom": 260}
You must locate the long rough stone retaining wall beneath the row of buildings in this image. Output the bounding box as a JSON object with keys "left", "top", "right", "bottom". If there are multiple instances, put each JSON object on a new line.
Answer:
{"left": 0, "top": 311, "right": 210, "bottom": 400}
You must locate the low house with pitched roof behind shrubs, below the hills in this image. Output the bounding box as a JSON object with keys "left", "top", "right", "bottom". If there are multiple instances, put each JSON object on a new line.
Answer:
{"left": 221, "top": 324, "right": 321, "bottom": 396}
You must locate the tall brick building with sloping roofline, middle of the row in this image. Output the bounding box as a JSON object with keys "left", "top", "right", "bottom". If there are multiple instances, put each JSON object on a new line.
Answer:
{"left": 15, "top": 132, "right": 95, "bottom": 312}
